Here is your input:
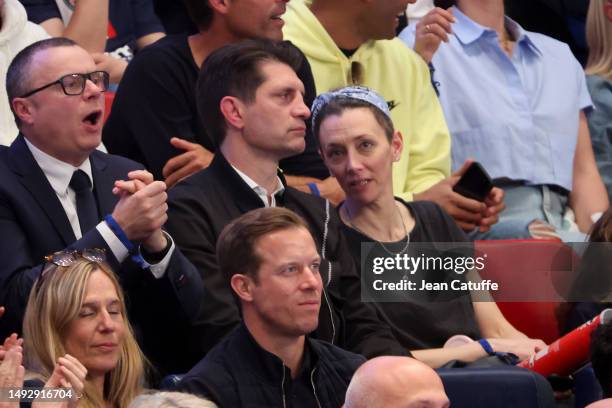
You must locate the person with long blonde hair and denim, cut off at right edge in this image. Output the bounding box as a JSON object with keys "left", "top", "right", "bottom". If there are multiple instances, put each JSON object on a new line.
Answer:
{"left": 586, "top": 0, "right": 612, "bottom": 199}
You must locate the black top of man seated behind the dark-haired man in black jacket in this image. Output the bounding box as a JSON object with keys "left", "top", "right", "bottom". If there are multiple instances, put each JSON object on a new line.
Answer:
{"left": 102, "top": 35, "right": 329, "bottom": 180}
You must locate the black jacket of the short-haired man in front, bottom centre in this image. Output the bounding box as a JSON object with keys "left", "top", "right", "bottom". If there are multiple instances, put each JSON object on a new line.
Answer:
{"left": 178, "top": 324, "right": 365, "bottom": 408}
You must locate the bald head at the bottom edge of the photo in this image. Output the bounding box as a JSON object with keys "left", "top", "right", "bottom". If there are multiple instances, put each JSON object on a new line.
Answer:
{"left": 344, "top": 357, "right": 450, "bottom": 408}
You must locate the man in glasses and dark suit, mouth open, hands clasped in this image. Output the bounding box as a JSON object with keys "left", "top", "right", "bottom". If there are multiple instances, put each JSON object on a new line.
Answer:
{"left": 0, "top": 38, "right": 203, "bottom": 380}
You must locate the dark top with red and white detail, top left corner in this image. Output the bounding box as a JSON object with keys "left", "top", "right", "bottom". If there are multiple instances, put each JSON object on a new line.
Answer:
{"left": 19, "top": 0, "right": 164, "bottom": 60}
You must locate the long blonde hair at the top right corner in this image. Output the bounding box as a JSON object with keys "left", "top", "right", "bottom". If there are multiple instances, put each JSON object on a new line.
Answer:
{"left": 586, "top": 0, "right": 612, "bottom": 81}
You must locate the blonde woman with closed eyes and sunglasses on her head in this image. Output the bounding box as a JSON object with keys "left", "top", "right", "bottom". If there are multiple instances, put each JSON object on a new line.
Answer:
{"left": 24, "top": 250, "right": 144, "bottom": 408}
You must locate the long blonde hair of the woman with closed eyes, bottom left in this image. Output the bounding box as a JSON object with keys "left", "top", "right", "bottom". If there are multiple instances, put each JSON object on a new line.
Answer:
{"left": 24, "top": 258, "right": 145, "bottom": 408}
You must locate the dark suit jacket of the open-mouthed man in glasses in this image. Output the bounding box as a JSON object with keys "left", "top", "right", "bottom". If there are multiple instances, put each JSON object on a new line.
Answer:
{"left": 0, "top": 135, "right": 203, "bottom": 373}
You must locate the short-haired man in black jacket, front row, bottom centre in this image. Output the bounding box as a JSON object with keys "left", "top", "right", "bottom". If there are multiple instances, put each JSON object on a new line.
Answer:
{"left": 179, "top": 208, "right": 365, "bottom": 408}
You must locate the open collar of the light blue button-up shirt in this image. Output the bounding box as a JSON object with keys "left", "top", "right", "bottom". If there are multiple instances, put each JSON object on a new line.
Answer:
{"left": 453, "top": 7, "right": 542, "bottom": 56}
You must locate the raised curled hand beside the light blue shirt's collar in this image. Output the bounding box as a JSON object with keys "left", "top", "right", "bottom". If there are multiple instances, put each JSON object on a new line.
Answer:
{"left": 414, "top": 7, "right": 456, "bottom": 63}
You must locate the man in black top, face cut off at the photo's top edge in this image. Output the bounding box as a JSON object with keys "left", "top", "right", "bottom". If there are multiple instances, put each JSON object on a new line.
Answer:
{"left": 103, "top": 0, "right": 343, "bottom": 202}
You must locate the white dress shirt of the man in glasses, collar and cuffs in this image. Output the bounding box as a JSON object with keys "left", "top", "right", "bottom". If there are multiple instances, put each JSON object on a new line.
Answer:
{"left": 24, "top": 138, "right": 175, "bottom": 279}
